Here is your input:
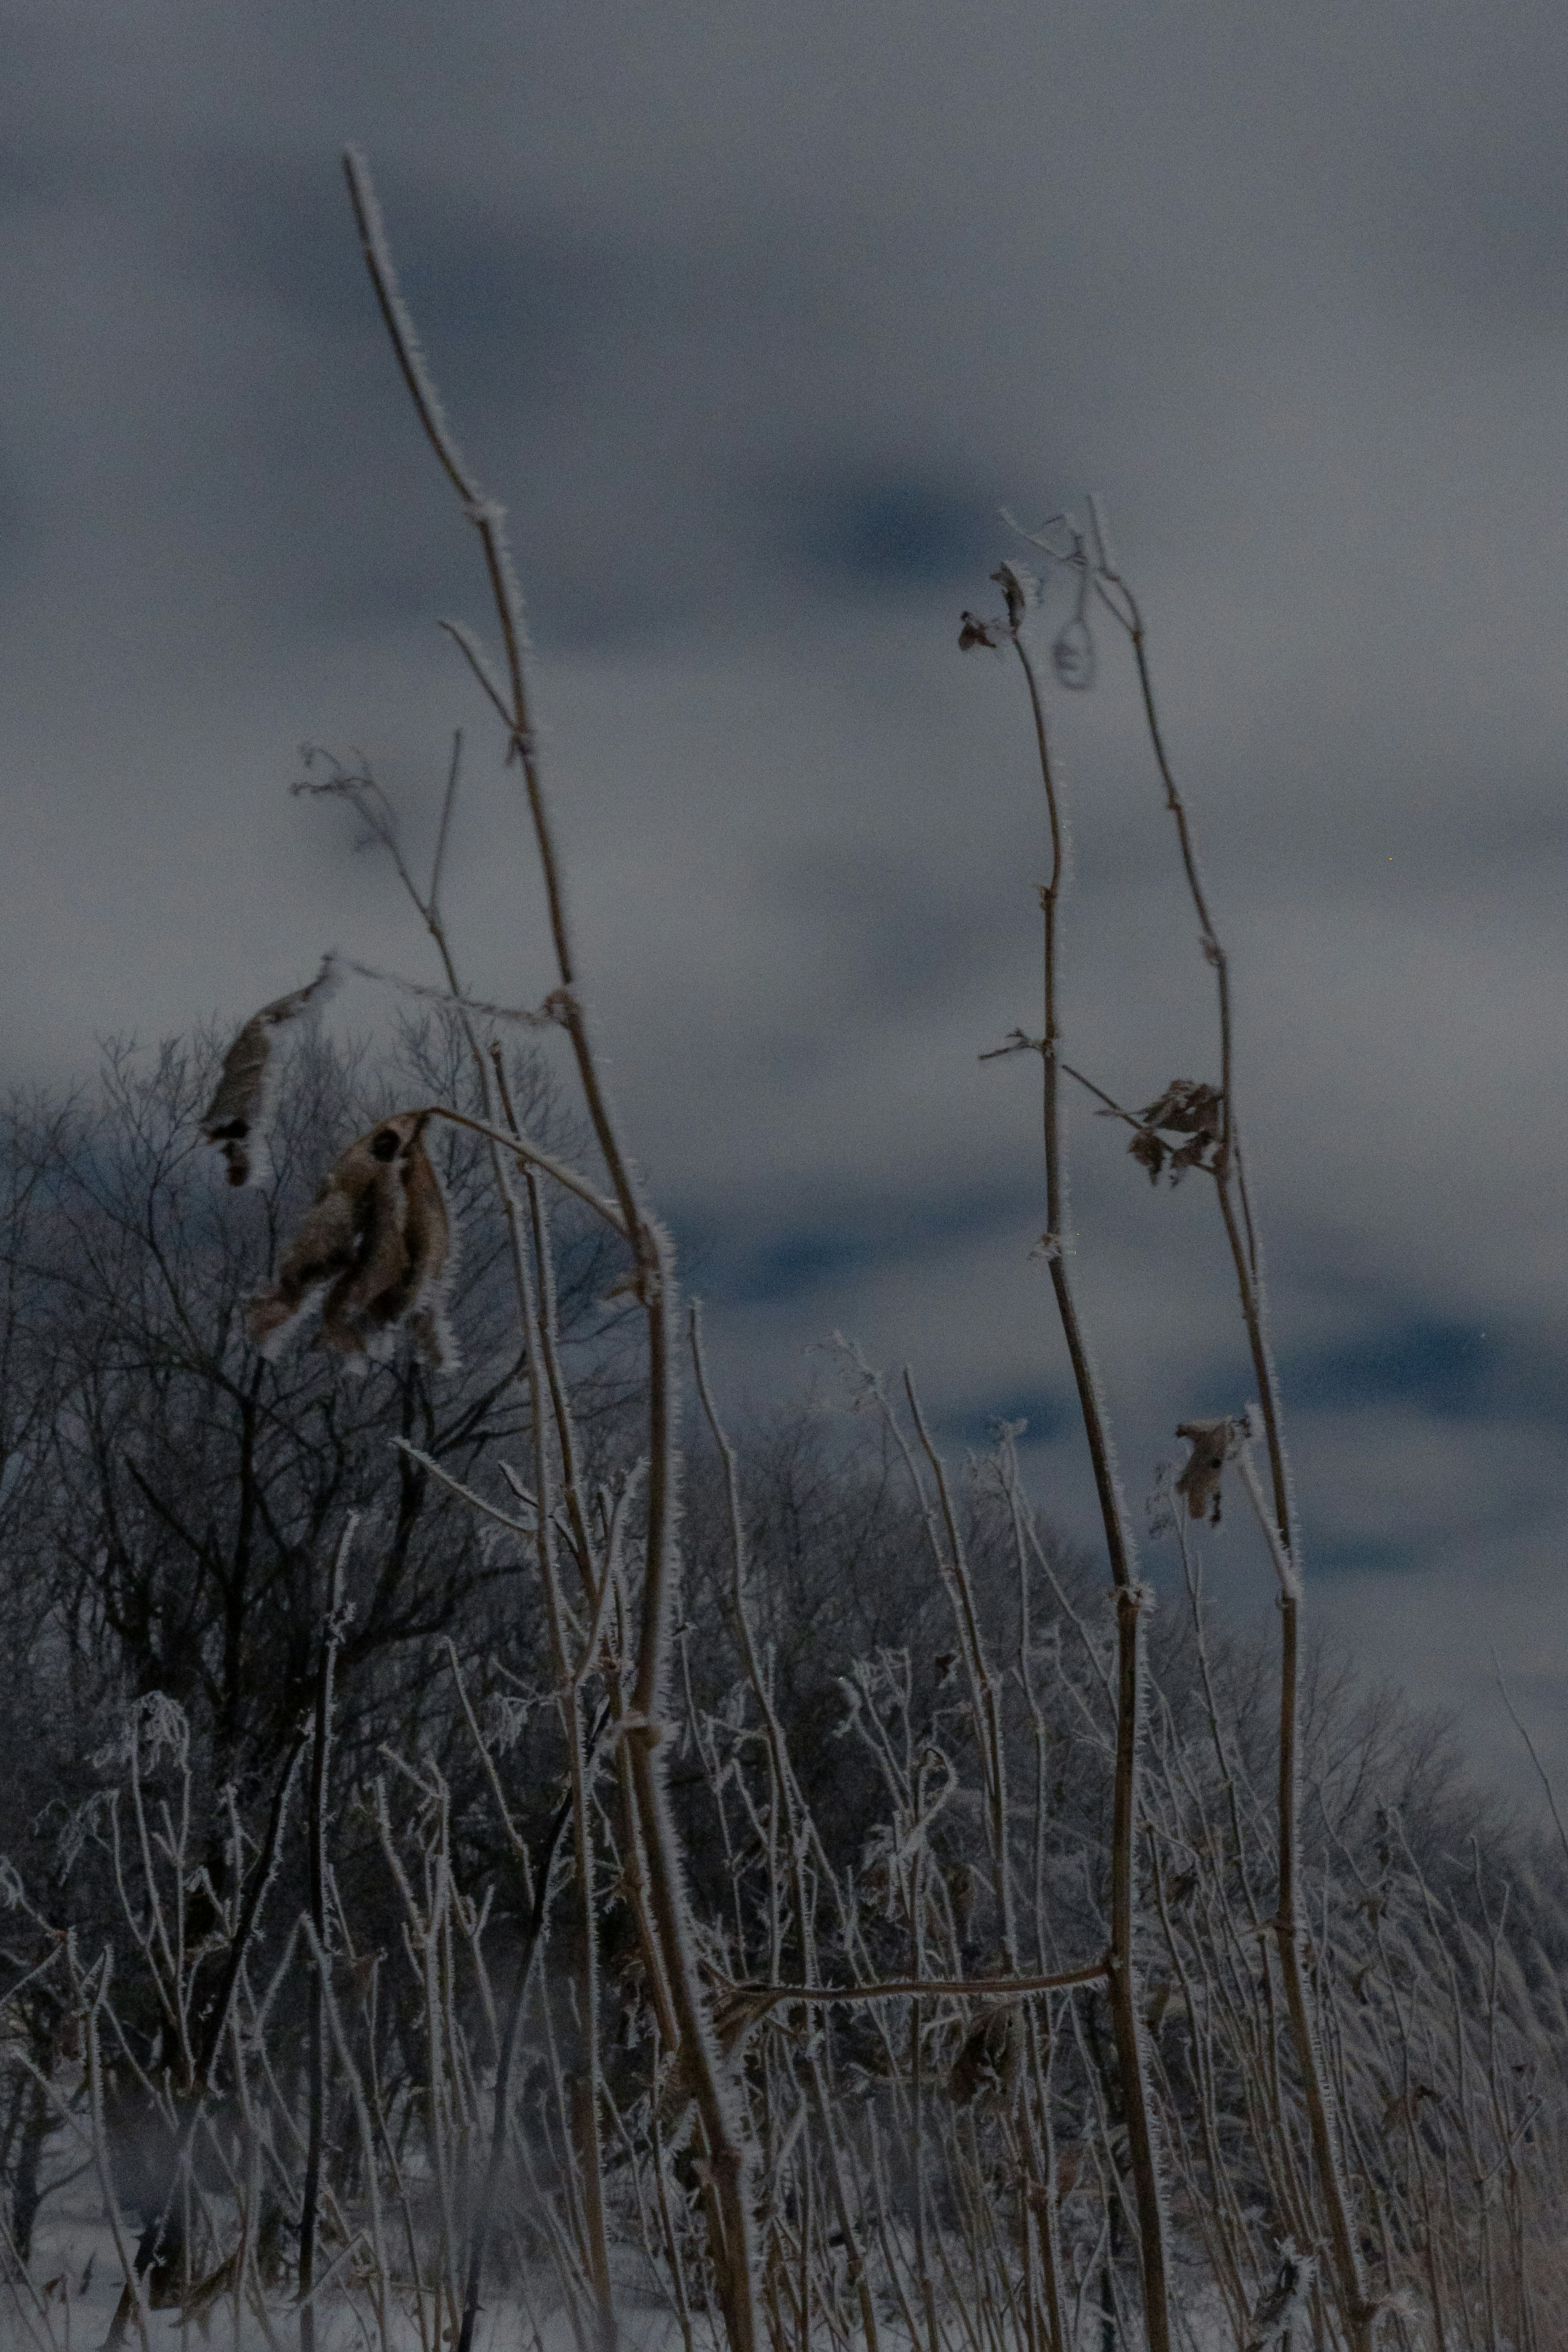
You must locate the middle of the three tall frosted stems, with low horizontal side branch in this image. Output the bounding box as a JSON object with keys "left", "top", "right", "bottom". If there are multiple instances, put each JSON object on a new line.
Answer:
{"left": 1004, "top": 607, "right": 1171, "bottom": 2352}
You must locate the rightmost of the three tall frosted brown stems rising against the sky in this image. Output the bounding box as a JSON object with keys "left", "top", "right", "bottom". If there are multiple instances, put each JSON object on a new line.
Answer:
{"left": 1093, "top": 524, "right": 1378, "bottom": 2352}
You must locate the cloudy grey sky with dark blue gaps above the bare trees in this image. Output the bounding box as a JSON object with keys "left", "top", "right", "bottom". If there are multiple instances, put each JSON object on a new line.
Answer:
{"left": 0, "top": 0, "right": 1568, "bottom": 1771}
